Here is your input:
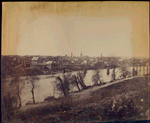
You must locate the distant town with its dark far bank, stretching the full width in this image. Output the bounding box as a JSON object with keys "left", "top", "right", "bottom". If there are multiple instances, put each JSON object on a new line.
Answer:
{"left": 1, "top": 55, "right": 150, "bottom": 75}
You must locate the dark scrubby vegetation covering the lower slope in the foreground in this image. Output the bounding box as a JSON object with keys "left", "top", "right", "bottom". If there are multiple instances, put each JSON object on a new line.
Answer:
{"left": 17, "top": 90, "right": 148, "bottom": 122}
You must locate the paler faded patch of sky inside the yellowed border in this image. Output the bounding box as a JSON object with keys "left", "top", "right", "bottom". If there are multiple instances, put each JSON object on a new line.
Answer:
{"left": 17, "top": 16, "right": 132, "bottom": 56}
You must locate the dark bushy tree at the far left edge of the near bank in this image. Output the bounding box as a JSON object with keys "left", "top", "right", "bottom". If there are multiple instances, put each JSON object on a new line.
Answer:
{"left": 1, "top": 76, "right": 24, "bottom": 120}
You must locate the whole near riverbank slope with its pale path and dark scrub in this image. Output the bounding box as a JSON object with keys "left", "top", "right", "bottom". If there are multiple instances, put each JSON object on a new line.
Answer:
{"left": 9, "top": 76, "right": 150, "bottom": 122}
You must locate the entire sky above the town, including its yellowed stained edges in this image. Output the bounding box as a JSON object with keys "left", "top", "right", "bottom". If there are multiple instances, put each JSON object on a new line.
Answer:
{"left": 2, "top": 2, "right": 149, "bottom": 57}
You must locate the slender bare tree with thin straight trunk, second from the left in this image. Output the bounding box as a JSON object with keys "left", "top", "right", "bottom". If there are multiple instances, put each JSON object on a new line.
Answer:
{"left": 29, "top": 75, "right": 39, "bottom": 104}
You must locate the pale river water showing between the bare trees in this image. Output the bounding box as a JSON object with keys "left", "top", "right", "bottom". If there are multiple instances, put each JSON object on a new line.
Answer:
{"left": 2, "top": 67, "right": 149, "bottom": 105}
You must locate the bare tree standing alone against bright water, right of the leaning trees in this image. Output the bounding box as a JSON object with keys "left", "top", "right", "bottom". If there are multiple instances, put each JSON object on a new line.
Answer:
{"left": 92, "top": 69, "right": 102, "bottom": 85}
